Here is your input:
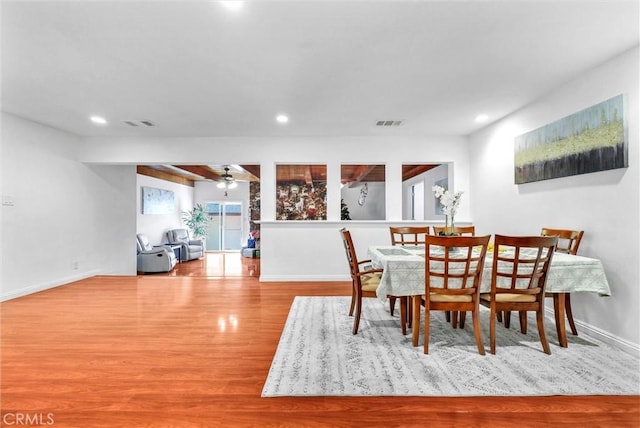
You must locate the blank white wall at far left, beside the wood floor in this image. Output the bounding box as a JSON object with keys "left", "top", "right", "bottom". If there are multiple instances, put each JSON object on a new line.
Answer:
{"left": 1, "top": 113, "right": 136, "bottom": 300}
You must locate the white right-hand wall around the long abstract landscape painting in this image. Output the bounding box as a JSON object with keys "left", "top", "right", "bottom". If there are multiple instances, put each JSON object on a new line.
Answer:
{"left": 470, "top": 48, "right": 640, "bottom": 347}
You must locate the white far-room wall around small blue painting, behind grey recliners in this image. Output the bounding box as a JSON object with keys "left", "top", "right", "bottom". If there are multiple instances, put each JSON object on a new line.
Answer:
{"left": 136, "top": 174, "right": 194, "bottom": 245}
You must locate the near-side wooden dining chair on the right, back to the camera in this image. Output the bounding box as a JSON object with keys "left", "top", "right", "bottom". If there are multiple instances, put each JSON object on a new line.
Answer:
{"left": 480, "top": 235, "right": 558, "bottom": 354}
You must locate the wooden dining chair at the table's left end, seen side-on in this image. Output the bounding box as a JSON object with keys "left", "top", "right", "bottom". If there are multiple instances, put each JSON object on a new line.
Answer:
{"left": 340, "top": 228, "right": 407, "bottom": 334}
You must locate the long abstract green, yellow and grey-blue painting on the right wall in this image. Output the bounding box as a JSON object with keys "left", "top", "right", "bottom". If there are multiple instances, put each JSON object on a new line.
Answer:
{"left": 514, "top": 95, "right": 629, "bottom": 184}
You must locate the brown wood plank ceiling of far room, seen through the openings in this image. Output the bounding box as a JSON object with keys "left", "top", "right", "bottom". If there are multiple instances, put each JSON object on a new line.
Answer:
{"left": 137, "top": 164, "right": 439, "bottom": 187}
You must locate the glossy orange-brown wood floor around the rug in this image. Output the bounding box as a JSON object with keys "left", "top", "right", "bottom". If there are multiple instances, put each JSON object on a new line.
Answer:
{"left": 0, "top": 255, "right": 640, "bottom": 427}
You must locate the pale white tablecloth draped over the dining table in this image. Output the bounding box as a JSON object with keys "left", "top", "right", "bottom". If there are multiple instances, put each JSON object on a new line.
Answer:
{"left": 368, "top": 245, "right": 611, "bottom": 300}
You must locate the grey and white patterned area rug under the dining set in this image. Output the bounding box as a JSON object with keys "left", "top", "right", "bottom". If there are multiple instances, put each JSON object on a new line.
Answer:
{"left": 262, "top": 297, "right": 640, "bottom": 397}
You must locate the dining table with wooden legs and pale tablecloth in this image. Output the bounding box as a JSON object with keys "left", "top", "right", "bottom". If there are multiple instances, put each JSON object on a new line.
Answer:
{"left": 367, "top": 245, "right": 611, "bottom": 348}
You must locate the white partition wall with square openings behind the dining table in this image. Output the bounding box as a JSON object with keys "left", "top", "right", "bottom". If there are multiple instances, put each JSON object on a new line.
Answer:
{"left": 80, "top": 136, "right": 470, "bottom": 281}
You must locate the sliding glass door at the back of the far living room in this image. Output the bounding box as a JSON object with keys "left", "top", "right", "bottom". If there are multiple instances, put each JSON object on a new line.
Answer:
{"left": 206, "top": 201, "right": 242, "bottom": 251}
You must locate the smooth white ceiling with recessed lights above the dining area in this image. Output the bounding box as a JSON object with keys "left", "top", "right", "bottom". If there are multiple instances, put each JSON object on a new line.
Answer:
{"left": 1, "top": 0, "right": 639, "bottom": 137}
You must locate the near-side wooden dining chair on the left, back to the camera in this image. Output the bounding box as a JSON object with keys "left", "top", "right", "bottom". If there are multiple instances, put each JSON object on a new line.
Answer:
{"left": 421, "top": 235, "right": 490, "bottom": 355}
